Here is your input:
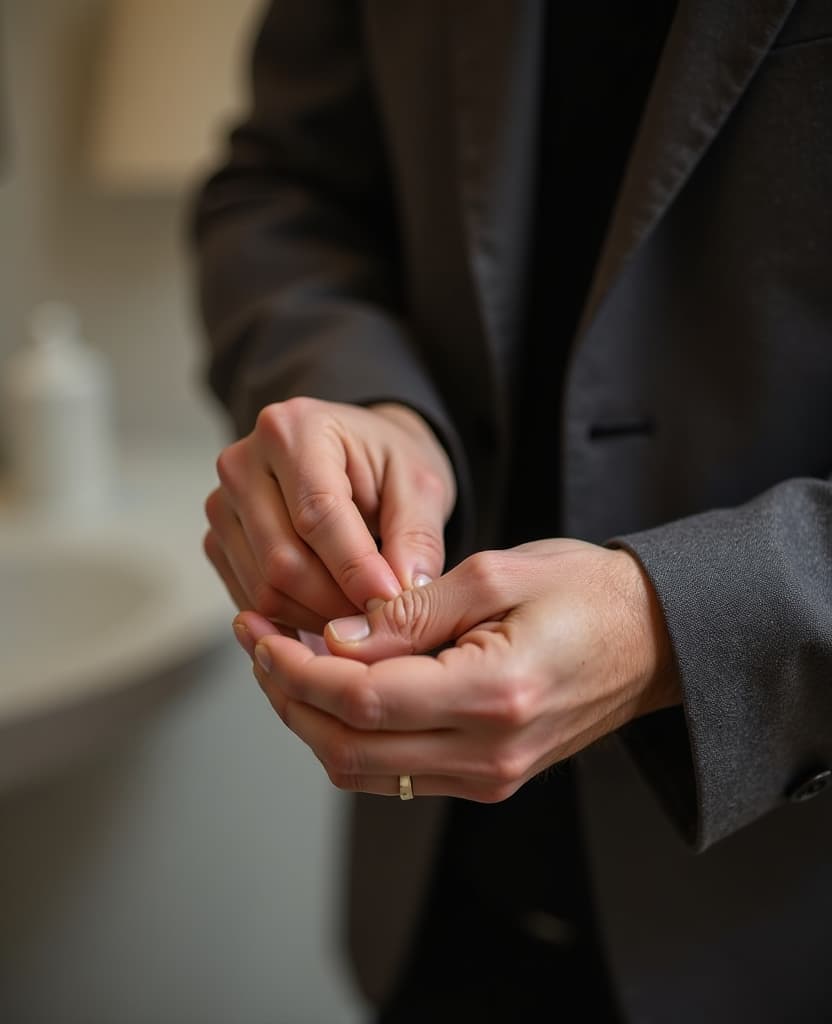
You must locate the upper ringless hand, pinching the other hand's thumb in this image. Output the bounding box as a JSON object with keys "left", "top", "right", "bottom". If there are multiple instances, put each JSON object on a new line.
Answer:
{"left": 205, "top": 398, "right": 456, "bottom": 633}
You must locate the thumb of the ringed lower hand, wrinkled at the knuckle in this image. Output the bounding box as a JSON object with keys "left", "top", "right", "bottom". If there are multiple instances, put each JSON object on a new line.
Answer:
{"left": 324, "top": 552, "right": 506, "bottom": 663}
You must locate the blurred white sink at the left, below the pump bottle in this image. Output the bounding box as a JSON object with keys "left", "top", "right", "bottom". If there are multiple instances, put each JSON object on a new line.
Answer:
{"left": 0, "top": 444, "right": 233, "bottom": 788}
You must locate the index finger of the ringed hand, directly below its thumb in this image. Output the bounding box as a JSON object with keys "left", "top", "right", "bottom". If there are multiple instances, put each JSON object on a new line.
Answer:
{"left": 255, "top": 630, "right": 514, "bottom": 732}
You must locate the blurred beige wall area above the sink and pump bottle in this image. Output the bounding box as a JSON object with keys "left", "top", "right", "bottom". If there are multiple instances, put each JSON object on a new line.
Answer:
{"left": 0, "top": 0, "right": 221, "bottom": 440}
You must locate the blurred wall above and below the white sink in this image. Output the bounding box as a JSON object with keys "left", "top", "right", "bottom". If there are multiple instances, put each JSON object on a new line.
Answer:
{"left": 0, "top": 0, "right": 363, "bottom": 1024}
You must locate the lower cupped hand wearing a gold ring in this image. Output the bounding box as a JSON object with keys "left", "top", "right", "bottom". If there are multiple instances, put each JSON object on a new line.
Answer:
{"left": 238, "top": 540, "right": 679, "bottom": 802}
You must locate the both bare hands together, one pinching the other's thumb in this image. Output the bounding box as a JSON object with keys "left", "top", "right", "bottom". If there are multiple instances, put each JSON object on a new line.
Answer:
{"left": 206, "top": 399, "right": 679, "bottom": 802}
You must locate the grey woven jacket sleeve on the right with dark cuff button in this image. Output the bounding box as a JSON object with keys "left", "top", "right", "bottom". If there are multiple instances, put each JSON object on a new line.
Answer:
{"left": 611, "top": 478, "right": 832, "bottom": 850}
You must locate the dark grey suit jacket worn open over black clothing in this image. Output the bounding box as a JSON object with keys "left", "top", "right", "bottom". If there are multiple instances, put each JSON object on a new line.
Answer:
{"left": 191, "top": 0, "right": 832, "bottom": 1022}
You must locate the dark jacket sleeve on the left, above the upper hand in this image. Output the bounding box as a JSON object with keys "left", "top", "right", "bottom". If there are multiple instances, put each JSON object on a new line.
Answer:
{"left": 193, "top": 0, "right": 471, "bottom": 547}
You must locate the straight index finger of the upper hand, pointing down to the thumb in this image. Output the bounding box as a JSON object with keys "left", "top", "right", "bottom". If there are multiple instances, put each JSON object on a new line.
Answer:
{"left": 263, "top": 403, "right": 401, "bottom": 608}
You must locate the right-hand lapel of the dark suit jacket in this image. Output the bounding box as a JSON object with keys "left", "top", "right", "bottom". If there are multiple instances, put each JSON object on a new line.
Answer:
{"left": 579, "top": 0, "right": 795, "bottom": 337}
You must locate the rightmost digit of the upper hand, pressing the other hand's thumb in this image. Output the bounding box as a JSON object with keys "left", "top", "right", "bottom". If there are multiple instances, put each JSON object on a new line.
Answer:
{"left": 379, "top": 461, "right": 449, "bottom": 588}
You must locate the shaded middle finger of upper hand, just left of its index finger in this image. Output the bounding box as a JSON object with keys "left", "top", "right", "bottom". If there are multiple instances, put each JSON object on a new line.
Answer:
{"left": 227, "top": 464, "right": 364, "bottom": 620}
